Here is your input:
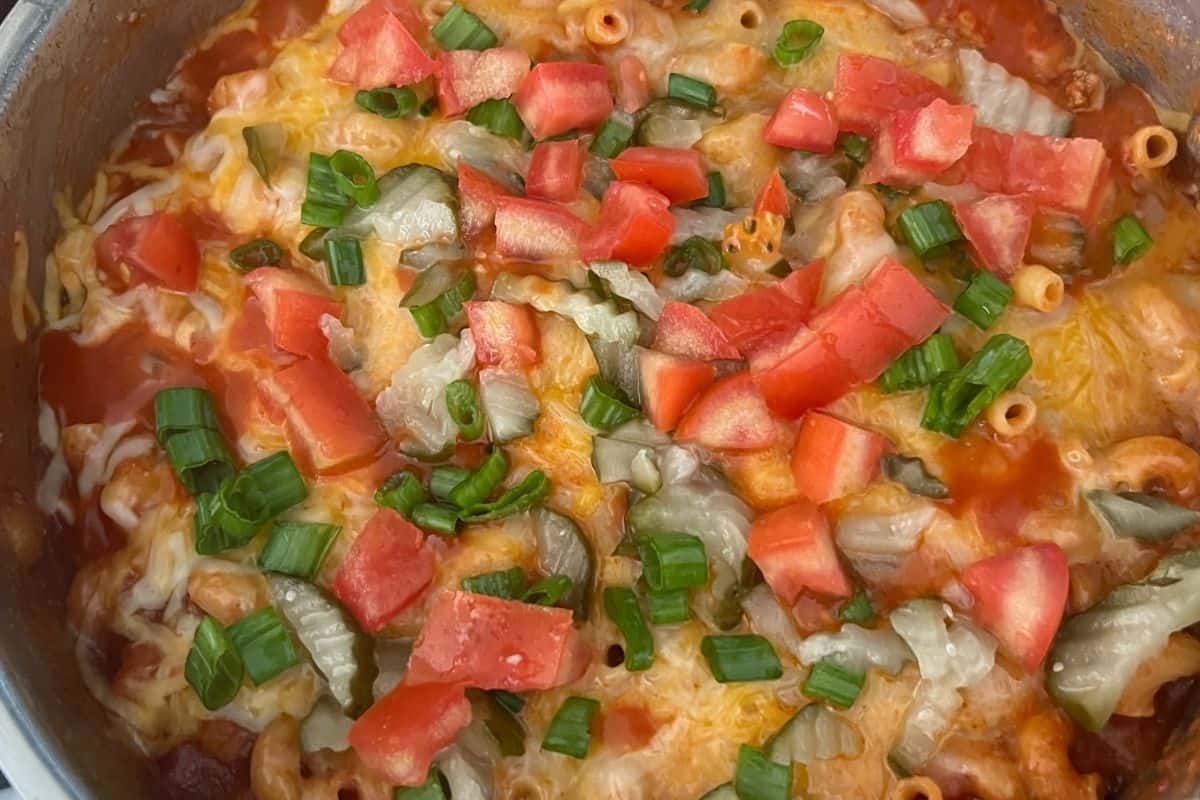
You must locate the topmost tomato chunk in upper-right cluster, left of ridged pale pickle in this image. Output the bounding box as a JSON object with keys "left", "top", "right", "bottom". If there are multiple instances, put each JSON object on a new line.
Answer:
{"left": 833, "top": 53, "right": 950, "bottom": 134}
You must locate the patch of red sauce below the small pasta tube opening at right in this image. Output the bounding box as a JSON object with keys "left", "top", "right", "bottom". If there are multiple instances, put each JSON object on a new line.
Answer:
{"left": 941, "top": 435, "right": 1073, "bottom": 536}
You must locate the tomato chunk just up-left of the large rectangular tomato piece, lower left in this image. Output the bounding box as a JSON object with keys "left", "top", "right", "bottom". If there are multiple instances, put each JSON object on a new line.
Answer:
{"left": 334, "top": 509, "right": 433, "bottom": 633}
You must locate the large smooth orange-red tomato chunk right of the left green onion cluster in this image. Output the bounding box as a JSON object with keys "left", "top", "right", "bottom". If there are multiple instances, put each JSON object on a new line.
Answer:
{"left": 268, "top": 359, "right": 386, "bottom": 471}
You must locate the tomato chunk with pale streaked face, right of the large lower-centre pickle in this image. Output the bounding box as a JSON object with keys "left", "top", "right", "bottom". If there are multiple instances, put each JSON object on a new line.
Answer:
{"left": 748, "top": 500, "right": 852, "bottom": 599}
